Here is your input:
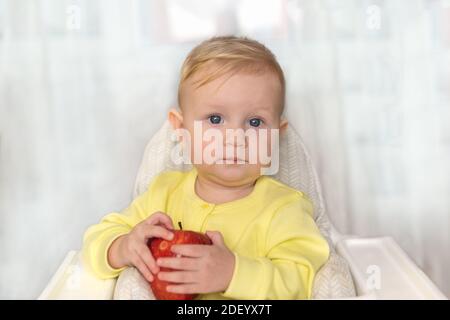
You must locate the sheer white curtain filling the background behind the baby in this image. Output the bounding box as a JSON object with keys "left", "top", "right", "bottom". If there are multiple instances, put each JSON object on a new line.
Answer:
{"left": 0, "top": 0, "right": 450, "bottom": 298}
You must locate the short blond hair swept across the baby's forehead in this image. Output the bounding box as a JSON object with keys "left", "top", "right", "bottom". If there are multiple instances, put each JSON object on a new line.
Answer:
{"left": 178, "top": 36, "right": 286, "bottom": 114}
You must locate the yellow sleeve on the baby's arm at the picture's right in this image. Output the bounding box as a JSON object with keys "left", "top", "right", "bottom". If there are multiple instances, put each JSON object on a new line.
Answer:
{"left": 223, "top": 197, "right": 329, "bottom": 300}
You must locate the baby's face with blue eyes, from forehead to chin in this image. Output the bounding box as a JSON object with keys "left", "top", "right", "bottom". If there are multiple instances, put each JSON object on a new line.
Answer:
{"left": 172, "top": 72, "right": 282, "bottom": 186}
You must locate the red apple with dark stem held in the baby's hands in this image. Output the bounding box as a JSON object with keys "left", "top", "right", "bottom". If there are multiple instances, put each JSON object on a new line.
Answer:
{"left": 147, "top": 222, "right": 212, "bottom": 300}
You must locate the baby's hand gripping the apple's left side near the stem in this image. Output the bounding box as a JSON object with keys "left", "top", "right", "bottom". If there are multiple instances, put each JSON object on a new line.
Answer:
{"left": 108, "top": 212, "right": 173, "bottom": 281}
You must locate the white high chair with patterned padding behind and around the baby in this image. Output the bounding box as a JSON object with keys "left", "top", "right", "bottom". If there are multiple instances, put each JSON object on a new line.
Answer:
{"left": 39, "top": 121, "right": 446, "bottom": 299}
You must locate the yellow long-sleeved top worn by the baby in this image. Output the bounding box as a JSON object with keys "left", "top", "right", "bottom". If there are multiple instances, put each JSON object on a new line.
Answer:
{"left": 83, "top": 168, "right": 329, "bottom": 299}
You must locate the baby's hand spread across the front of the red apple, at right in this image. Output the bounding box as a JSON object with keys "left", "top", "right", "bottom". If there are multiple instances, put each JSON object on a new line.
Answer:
{"left": 157, "top": 231, "right": 235, "bottom": 294}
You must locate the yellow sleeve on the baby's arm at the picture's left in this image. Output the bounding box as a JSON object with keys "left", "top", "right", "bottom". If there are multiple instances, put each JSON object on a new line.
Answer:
{"left": 82, "top": 188, "right": 152, "bottom": 279}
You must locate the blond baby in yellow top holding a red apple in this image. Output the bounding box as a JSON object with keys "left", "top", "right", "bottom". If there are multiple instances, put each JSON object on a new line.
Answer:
{"left": 83, "top": 36, "right": 329, "bottom": 299}
